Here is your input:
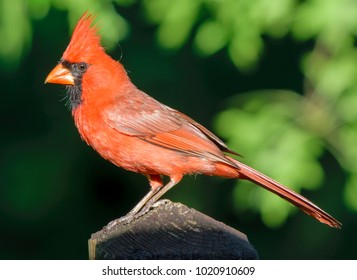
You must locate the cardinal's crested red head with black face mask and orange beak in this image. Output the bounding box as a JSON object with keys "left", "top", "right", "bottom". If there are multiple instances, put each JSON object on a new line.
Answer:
{"left": 45, "top": 13, "right": 127, "bottom": 110}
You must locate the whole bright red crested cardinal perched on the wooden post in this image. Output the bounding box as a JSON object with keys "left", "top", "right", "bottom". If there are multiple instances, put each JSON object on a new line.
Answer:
{"left": 45, "top": 13, "right": 341, "bottom": 228}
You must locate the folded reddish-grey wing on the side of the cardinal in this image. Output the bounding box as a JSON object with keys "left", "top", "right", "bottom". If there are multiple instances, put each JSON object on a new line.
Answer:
{"left": 103, "top": 90, "right": 239, "bottom": 167}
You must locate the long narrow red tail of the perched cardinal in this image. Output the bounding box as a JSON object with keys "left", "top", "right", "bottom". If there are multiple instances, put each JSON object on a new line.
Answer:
{"left": 230, "top": 158, "right": 342, "bottom": 228}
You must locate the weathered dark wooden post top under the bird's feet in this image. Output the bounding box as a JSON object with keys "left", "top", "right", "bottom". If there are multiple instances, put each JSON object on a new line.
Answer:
{"left": 88, "top": 200, "right": 258, "bottom": 260}
